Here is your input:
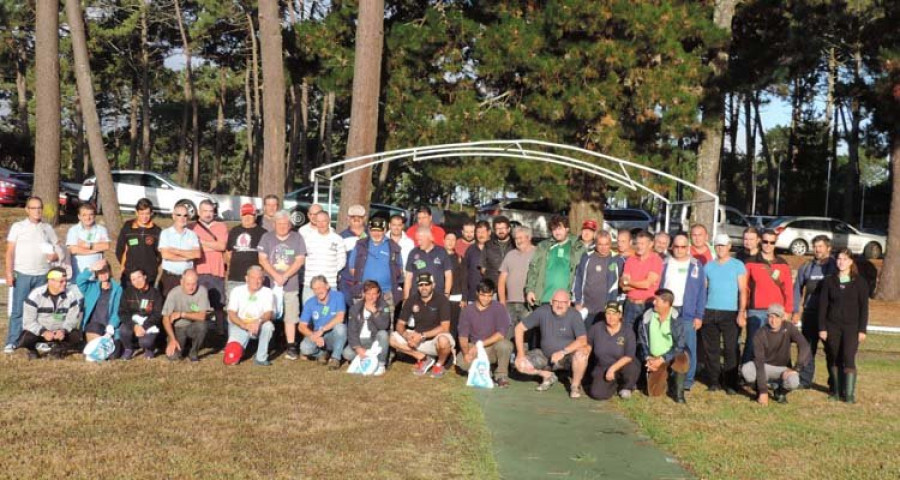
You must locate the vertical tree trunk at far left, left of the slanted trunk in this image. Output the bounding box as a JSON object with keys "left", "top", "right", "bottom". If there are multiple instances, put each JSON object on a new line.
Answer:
{"left": 33, "top": 0, "right": 61, "bottom": 225}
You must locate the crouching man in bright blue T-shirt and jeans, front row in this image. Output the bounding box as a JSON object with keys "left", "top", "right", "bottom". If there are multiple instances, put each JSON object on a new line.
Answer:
{"left": 297, "top": 275, "right": 347, "bottom": 370}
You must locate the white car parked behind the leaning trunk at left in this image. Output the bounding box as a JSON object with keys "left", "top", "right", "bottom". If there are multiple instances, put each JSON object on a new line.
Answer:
{"left": 78, "top": 170, "right": 218, "bottom": 218}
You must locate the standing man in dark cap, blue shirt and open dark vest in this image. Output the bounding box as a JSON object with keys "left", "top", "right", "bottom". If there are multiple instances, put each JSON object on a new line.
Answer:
{"left": 345, "top": 217, "right": 403, "bottom": 318}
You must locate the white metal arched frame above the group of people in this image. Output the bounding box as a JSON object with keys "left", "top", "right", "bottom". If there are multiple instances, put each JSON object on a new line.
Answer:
{"left": 309, "top": 140, "right": 719, "bottom": 237}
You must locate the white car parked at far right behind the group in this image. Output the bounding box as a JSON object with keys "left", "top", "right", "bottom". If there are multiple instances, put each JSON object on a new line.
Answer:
{"left": 768, "top": 217, "right": 887, "bottom": 259}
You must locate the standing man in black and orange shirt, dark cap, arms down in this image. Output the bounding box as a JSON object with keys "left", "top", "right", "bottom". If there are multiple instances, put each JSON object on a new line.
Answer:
{"left": 116, "top": 198, "right": 162, "bottom": 288}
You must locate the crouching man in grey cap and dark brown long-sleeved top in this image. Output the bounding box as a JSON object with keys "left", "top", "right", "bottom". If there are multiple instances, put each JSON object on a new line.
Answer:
{"left": 741, "top": 303, "right": 812, "bottom": 405}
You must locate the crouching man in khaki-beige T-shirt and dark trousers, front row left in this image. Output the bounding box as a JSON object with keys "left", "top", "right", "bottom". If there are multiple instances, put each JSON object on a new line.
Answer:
{"left": 162, "top": 268, "right": 209, "bottom": 362}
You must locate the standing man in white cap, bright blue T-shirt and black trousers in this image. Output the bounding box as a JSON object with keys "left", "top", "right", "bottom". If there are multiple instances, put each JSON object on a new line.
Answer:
{"left": 700, "top": 233, "right": 747, "bottom": 395}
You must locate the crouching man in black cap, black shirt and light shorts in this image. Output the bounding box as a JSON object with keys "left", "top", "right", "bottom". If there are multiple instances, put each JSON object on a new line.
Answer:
{"left": 390, "top": 272, "right": 456, "bottom": 377}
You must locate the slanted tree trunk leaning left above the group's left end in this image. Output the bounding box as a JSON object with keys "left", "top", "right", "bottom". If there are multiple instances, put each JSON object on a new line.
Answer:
{"left": 65, "top": 0, "right": 122, "bottom": 235}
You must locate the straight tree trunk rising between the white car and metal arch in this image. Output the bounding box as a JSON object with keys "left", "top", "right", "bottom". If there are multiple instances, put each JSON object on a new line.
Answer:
{"left": 259, "top": 0, "right": 285, "bottom": 198}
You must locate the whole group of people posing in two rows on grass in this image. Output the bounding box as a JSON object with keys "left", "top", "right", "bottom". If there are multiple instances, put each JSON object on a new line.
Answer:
{"left": 4, "top": 196, "right": 868, "bottom": 404}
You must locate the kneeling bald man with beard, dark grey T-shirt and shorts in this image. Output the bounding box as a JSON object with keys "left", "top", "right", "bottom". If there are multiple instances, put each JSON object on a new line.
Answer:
{"left": 515, "top": 290, "right": 591, "bottom": 398}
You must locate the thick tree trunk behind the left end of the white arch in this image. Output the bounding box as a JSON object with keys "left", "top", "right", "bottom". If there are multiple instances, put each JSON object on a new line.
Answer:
{"left": 338, "top": 0, "right": 384, "bottom": 229}
